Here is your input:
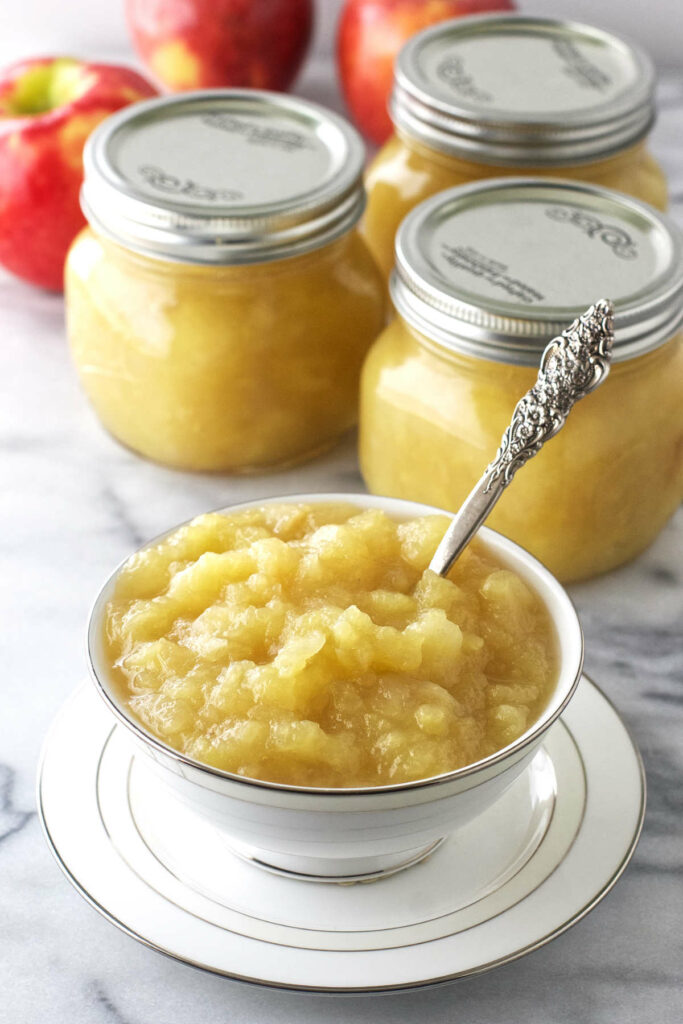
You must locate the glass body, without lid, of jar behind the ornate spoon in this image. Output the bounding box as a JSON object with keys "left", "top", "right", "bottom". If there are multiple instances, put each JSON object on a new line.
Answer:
{"left": 360, "top": 317, "right": 683, "bottom": 583}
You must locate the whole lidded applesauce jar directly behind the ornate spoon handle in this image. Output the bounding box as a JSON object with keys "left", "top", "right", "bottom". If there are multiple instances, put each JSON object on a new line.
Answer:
{"left": 360, "top": 178, "right": 683, "bottom": 582}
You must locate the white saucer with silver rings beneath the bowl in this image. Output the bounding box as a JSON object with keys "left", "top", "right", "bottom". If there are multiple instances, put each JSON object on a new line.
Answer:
{"left": 39, "top": 678, "right": 645, "bottom": 992}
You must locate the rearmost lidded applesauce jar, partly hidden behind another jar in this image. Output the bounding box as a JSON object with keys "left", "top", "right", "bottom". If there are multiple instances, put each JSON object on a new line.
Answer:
{"left": 361, "top": 14, "right": 667, "bottom": 278}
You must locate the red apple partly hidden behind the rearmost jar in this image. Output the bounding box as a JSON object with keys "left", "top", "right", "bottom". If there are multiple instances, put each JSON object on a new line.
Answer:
{"left": 337, "top": 0, "right": 515, "bottom": 144}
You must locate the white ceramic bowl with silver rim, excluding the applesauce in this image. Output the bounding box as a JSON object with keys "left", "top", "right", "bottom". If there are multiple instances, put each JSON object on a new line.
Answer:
{"left": 88, "top": 494, "right": 584, "bottom": 882}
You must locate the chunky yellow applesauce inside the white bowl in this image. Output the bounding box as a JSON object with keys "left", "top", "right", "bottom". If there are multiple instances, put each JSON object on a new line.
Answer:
{"left": 104, "top": 503, "right": 557, "bottom": 787}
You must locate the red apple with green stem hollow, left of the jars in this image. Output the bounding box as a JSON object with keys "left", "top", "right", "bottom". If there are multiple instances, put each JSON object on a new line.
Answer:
{"left": 0, "top": 57, "right": 157, "bottom": 291}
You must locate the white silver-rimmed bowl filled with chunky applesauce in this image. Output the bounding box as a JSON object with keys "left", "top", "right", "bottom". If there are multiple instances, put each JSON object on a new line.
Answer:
{"left": 88, "top": 495, "right": 583, "bottom": 882}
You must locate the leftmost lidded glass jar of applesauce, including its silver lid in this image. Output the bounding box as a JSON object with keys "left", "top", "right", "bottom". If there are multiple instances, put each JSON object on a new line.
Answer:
{"left": 66, "top": 90, "right": 385, "bottom": 472}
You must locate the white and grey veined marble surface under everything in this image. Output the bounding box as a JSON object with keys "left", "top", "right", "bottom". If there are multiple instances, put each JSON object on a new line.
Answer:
{"left": 0, "top": 48, "right": 683, "bottom": 1024}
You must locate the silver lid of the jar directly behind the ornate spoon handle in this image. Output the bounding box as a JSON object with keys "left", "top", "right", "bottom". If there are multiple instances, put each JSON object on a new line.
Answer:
{"left": 391, "top": 178, "right": 683, "bottom": 366}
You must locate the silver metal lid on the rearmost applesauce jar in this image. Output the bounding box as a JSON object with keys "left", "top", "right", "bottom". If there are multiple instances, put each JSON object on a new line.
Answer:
{"left": 390, "top": 14, "right": 654, "bottom": 167}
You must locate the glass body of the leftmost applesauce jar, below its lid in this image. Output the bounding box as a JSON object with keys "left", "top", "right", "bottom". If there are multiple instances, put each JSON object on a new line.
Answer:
{"left": 66, "top": 227, "right": 385, "bottom": 472}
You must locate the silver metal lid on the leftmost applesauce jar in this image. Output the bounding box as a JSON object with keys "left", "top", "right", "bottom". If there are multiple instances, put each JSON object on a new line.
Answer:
{"left": 81, "top": 89, "right": 365, "bottom": 263}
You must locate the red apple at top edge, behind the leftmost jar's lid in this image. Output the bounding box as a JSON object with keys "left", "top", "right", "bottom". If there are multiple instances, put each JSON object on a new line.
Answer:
{"left": 126, "top": 0, "right": 313, "bottom": 92}
